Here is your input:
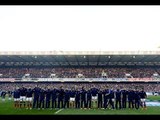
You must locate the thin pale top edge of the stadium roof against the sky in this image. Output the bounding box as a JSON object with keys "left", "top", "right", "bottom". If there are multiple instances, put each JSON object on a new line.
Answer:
{"left": 0, "top": 50, "right": 160, "bottom": 55}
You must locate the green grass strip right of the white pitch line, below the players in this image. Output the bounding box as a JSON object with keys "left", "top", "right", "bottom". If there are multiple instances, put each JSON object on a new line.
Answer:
{"left": 55, "top": 107, "right": 160, "bottom": 115}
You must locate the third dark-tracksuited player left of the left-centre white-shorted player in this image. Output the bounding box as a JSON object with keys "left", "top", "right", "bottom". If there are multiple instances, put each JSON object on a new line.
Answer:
{"left": 51, "top": 88, "right": 58, "bottom": 109}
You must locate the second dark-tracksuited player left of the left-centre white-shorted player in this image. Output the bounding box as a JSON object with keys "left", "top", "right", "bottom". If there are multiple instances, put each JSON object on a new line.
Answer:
{"left": 58, "top": 86, "right": 65, "bottom": 108}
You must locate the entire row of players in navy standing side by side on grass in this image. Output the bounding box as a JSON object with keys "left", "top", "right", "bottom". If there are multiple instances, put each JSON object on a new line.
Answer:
{"left": 14, "top": 86, "right": 147, "bottom": 109}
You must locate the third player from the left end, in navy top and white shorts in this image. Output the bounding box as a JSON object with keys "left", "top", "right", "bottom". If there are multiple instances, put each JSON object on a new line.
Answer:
{"left": 26, "top": 87, "right": 33, "bottom": 110}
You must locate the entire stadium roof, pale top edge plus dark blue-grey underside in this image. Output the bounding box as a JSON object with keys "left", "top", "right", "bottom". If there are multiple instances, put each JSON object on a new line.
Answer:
{"left": 0, "top": 51, "right": 160, "bottom": 67}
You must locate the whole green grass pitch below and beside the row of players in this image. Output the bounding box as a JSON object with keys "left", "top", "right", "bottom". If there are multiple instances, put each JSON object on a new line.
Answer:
{"left": 0, "top": 96, "right": 160, "bottom": 115}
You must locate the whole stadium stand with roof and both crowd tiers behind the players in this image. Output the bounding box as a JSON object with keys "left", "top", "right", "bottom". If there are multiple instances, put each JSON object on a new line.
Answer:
{"left": 0, "top": 51, "right": 160, "bottom": 92}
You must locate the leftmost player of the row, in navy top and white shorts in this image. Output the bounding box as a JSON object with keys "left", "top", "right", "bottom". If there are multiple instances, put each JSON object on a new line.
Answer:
{"left": 13, "top": 87, "right": 20, "bottom": 108}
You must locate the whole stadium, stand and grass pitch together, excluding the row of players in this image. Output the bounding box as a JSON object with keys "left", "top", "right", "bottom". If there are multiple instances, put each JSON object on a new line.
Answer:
{"left": 0, "top": 51, "right": 160, "bottom": 114}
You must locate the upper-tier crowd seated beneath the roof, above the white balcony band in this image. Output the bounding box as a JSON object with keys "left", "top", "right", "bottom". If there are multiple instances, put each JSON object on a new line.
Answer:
{"left": 0, "top": 68, "right": 160, "bottom": 78}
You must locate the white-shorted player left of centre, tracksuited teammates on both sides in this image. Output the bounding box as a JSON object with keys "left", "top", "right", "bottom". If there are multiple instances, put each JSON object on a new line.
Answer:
{"left": 69, "top": 87, "right": 76, "bottom": 108}
